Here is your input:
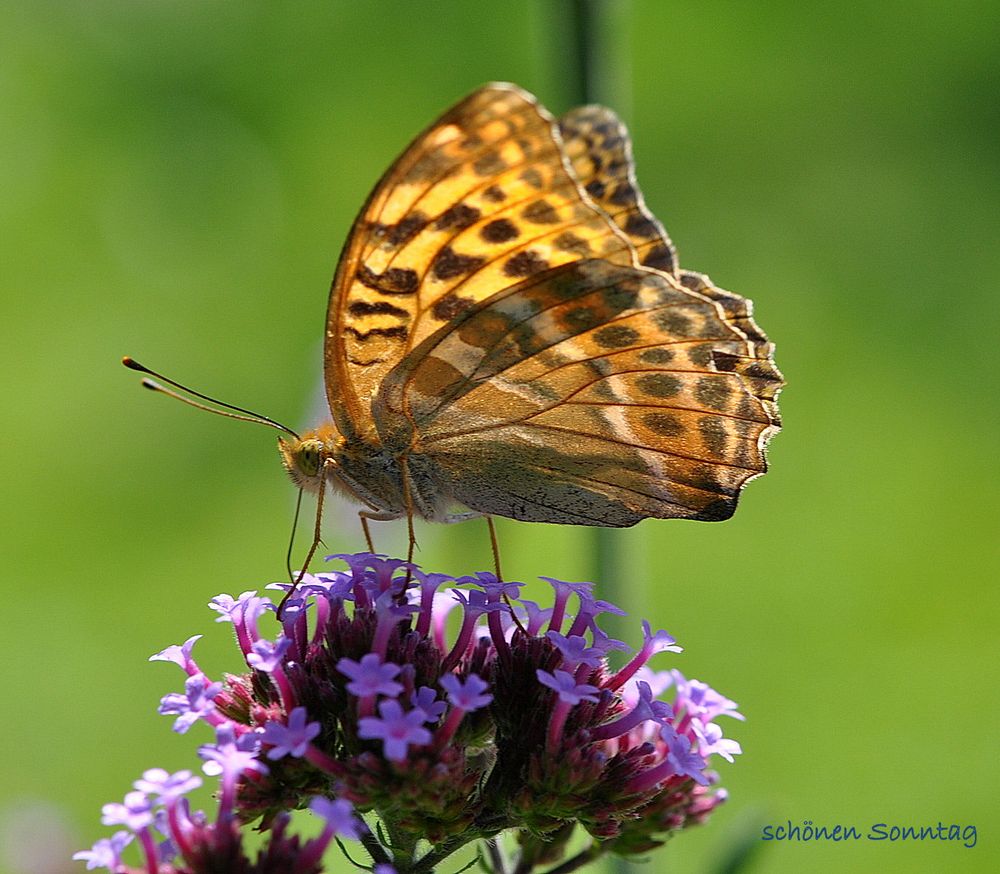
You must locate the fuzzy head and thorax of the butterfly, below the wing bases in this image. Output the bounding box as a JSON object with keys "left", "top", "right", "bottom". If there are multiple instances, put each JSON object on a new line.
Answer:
{"left": 278, "top": 422, "right": 447, "bottom": 519}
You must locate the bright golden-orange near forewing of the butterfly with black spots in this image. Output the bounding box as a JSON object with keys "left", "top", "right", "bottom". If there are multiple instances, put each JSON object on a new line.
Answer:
{"left": 326, "top": 85, "right": 635, "bottom": 433}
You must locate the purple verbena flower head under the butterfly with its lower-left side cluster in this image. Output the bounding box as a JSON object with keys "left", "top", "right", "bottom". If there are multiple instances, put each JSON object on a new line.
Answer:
{"left": 77, "top": 553, "right": 742, "bottom": 874}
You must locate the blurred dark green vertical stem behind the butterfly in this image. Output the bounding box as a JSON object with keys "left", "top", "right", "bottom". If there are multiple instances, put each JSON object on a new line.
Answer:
{"left": 552, "top": 6, "right": 635, "bottom": 874}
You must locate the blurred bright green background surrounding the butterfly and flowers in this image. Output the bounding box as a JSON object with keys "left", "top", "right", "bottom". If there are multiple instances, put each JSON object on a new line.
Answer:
{"left": 0, "top": 0, "right": 1000, "bottom": 874}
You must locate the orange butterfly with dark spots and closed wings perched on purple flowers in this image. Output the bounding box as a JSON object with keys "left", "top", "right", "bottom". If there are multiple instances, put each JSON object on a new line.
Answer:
{"left": 280, "top": 83, "right": 783, "bottom": 543}
